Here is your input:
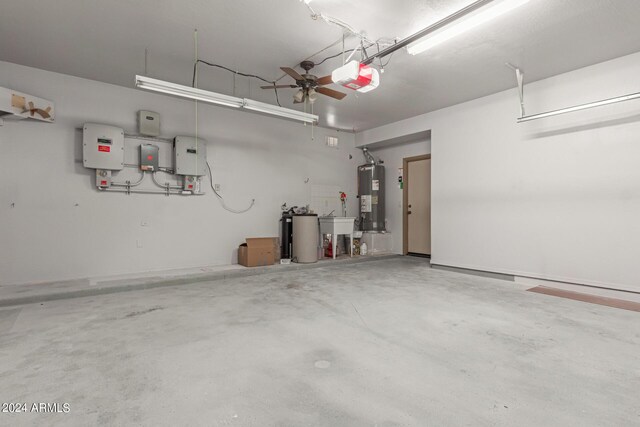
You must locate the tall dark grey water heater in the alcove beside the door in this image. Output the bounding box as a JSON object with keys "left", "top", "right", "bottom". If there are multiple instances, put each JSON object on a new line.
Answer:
{"left": 358, "top": 148, "right": 386, "bottom": 233}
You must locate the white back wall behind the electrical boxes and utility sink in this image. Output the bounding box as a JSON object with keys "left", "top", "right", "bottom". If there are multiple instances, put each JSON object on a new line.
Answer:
{"left": 0, "top": 62, "right": 361, "bottom": 284}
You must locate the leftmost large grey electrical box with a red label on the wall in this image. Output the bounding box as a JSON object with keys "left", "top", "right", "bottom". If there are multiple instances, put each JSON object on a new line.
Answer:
{"left": 82, "top": 123, "right": 124, "bottom": 170}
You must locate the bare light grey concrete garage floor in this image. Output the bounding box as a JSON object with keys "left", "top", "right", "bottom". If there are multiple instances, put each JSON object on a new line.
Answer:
{"left": 0, "top": 258, "right": 640, "bottom": 426}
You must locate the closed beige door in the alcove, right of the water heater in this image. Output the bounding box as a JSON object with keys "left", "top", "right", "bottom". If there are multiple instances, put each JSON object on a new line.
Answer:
{"left": 407, "top": 159, "right": 431, "bottom": 255}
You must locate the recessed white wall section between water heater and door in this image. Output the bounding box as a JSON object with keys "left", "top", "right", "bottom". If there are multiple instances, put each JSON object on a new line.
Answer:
{"left": 364, "top": 139, "right": 431, "bottom": 254}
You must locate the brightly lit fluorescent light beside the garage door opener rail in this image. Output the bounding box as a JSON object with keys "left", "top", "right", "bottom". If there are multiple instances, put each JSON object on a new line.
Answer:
{"left": 407, "top": 0, "right": 529, "bottom": 55}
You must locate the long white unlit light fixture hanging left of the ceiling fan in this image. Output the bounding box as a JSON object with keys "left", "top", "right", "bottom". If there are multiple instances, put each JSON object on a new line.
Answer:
{"left": 136, "top": 76, "right": 318, "bottom": 123}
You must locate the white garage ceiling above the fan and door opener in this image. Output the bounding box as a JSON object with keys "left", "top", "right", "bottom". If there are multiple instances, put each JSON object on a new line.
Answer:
{"left": 0, "top": 0, "right": 640, "bottom": 131}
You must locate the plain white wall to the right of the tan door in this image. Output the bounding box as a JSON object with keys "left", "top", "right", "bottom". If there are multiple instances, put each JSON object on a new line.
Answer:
{"left": 356, "top": 49, "right": 640, "bottom": 291}
